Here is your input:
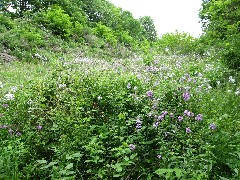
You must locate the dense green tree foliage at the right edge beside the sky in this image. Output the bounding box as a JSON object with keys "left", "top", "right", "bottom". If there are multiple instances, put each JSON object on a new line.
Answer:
{"left": 200, "top": 0, "right": 240, "bottom": 70}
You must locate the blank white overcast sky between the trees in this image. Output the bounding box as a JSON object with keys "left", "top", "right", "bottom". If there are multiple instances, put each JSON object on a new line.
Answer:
{"left": 108, "top": 0, "right": 202, "bottom": 37}
